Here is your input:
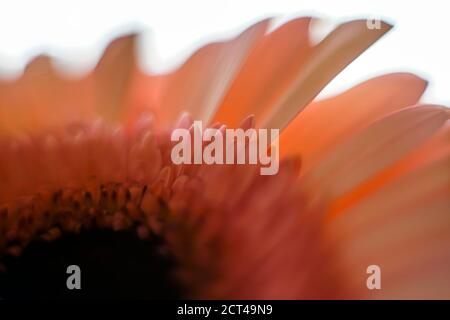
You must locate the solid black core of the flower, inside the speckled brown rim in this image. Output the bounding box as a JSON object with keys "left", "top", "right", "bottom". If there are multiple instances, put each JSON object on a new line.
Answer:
{"left": 0, "top": 229, "right": 182, "bottom": 299}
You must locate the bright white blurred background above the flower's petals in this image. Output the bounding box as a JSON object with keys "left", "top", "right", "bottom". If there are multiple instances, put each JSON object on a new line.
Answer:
{"left": 0, "top": 0, "right": 450, "bottom": 105}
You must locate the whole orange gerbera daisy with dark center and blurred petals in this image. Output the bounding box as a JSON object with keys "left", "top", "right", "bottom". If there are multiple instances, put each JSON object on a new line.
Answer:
{"left": 0, "top": 18, "right": 450, "bottom": 299}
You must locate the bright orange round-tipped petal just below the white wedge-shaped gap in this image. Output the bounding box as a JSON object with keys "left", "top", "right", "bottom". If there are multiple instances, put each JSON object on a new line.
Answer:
{"left": 280, "top": 73, "right": 427, "bottom": 172}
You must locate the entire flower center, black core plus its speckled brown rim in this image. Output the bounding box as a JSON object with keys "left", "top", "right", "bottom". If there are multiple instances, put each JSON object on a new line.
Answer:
{"left": 0, "top": 184, "right": 182, "bottom": 299}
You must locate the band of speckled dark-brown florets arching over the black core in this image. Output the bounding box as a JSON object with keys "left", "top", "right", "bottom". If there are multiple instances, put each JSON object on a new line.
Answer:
{"left": 0, "top": 183, "right": 167, "bottom": 256}
